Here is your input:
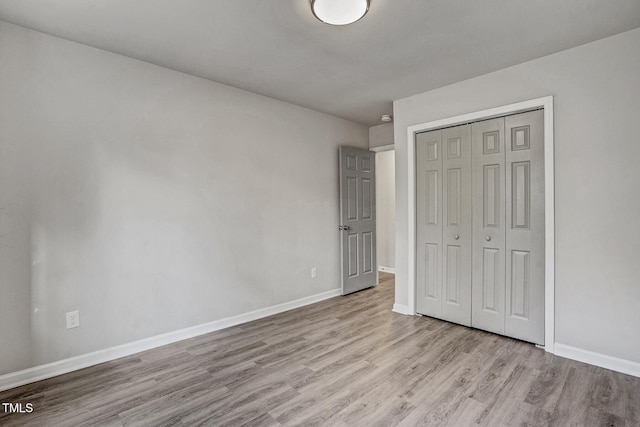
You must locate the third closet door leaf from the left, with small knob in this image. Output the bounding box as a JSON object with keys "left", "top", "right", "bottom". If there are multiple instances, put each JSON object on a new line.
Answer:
{"left": 471, "top": 118, "right": 505, "bottom": 334}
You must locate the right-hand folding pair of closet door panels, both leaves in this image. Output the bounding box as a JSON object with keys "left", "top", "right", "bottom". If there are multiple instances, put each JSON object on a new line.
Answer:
{"left": 471, "top": 111, "right": 544, "bottom": 344}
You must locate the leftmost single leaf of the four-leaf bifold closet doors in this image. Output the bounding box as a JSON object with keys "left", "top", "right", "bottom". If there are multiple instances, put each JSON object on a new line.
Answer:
{"left": 416, "top": 130, "right": 442, "bottom": 318}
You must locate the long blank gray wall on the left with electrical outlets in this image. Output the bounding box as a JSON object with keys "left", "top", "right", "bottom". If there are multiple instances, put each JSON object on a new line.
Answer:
{"left": 0, "top": 23, "right": 368, "bottom": 374}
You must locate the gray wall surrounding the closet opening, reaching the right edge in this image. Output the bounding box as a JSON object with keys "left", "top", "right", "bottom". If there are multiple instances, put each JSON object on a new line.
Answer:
{"left": 394, "top": 29, "right": 640, "bottom": 362}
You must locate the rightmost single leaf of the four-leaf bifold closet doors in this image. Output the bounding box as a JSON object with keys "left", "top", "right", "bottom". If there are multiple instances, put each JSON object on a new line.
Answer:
{"left": 504, "top": 111, "right": 544, "bottom": 344}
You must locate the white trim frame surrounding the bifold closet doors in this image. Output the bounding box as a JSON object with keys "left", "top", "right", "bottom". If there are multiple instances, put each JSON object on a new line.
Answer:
{"left": 407, "top": 96, "right": 555, "bottom": 353}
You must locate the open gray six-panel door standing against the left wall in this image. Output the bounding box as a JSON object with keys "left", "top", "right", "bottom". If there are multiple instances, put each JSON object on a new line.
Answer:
{"left": 339, "top": 146, "right": 377, "bottom": 295}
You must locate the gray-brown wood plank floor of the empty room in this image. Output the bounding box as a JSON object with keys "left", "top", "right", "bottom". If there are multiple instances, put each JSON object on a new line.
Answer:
{"left": 0, "top": 275, "right": 640, "bottom": 427}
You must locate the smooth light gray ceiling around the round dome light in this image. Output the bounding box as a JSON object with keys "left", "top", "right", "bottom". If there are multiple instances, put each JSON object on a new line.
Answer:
{"left": 0, "top": 0, "right": 640, "bottom": 126}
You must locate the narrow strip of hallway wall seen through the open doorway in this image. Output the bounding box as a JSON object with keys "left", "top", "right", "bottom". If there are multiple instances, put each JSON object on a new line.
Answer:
{"left": 376, "top": 150, "right": 396, "bottom": 268}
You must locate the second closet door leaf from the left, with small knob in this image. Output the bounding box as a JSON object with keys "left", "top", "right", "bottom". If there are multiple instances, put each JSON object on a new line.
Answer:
{"left": 442, "top": 125, "right": 472, "bottom": 326}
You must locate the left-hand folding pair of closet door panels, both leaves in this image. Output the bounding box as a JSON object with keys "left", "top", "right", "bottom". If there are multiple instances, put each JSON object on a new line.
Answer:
{"left": 416, "top": 125, "right": 471, "bottom": 326}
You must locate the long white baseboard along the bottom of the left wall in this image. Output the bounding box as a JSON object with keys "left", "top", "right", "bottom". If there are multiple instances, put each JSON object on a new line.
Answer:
{"left": 0, "top": 289, "right": 342, "bottom": 391}
